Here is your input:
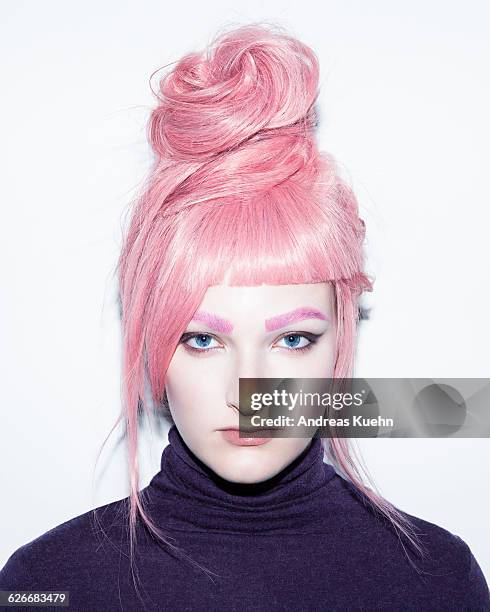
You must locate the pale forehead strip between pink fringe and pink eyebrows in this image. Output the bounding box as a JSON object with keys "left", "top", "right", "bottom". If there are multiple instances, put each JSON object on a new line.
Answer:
{"left": 191, "top": 283, "right": 334, "bottom": 324}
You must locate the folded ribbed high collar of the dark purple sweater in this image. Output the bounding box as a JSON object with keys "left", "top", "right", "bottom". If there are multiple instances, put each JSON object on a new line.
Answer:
{"left": 145, "top": 425, "right": 335, "bottom": 534}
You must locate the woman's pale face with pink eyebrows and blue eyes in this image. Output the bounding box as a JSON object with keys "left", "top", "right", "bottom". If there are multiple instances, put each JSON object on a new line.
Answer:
{"left": 166, "top": 283, "right": 337, "bottom": 483}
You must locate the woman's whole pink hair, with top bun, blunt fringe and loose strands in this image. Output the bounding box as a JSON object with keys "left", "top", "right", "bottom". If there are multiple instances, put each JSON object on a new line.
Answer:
{"left": 100, "top": 24, "right": 423, "bottom": 584}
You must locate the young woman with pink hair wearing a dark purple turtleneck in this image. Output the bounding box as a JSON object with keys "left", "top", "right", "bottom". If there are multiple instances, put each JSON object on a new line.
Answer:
{"left": 0, "top": 25, "right": 490, "bottom": 611}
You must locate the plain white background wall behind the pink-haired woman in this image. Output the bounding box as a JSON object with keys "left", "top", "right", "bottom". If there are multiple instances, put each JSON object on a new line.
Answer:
{"left": 0, "top": 0, "right": 490, "bottom": 580}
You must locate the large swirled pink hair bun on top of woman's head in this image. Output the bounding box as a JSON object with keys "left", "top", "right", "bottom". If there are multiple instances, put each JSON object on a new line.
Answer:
{"left": 148, "top": 25, "right": 319, "bottom": 161}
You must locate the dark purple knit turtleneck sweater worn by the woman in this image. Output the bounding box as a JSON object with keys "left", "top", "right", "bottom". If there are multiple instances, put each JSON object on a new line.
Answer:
{"left": 0, "top": 426, "right": 490, "bottom": 612}
